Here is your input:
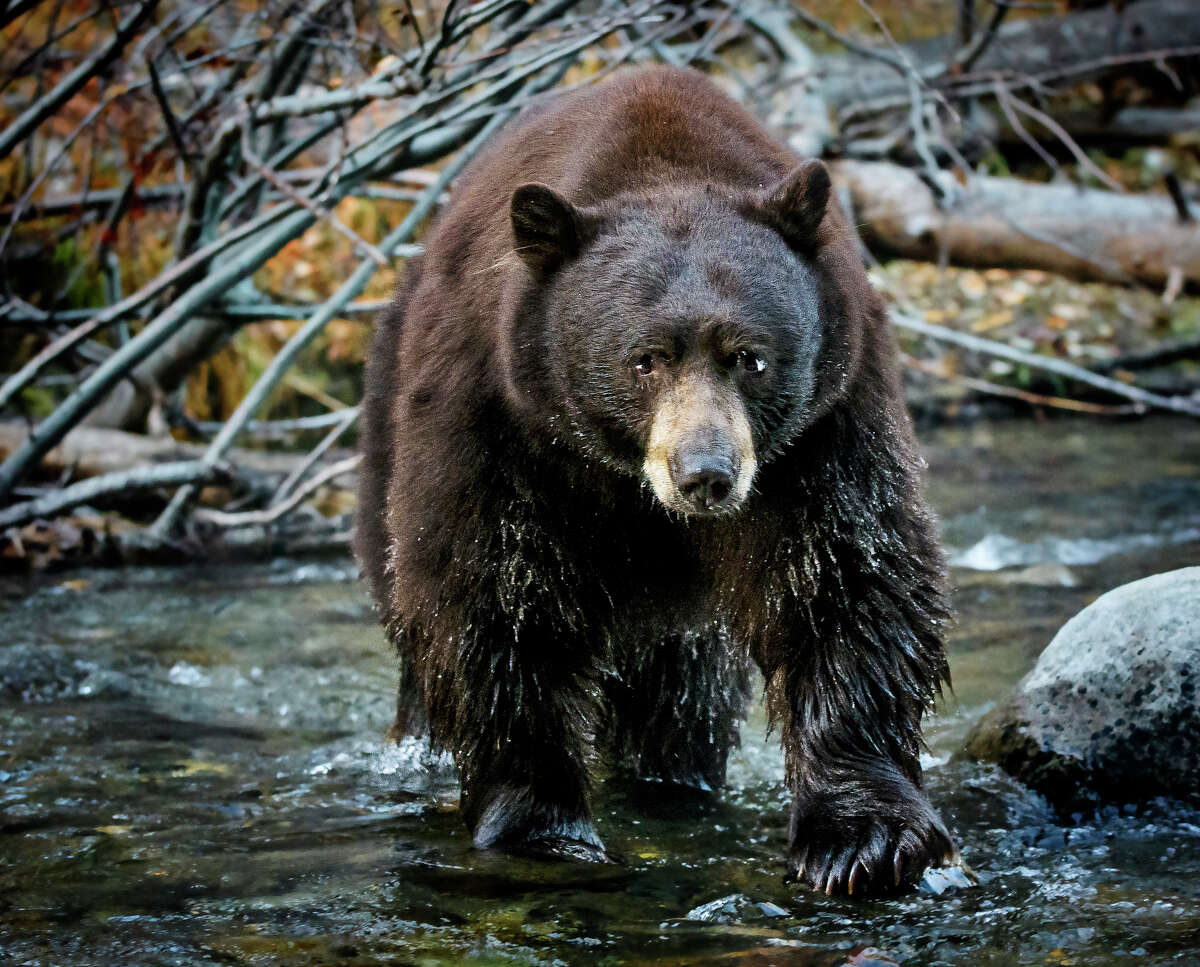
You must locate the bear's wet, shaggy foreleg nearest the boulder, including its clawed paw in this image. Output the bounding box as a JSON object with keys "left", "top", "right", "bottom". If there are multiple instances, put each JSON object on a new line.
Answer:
{"left": 756, "top": 488, "right": 956, "bottom": 894}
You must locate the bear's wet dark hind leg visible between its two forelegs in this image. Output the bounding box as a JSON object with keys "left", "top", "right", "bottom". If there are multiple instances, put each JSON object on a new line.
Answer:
{"left": 606, "top": 629, "right": 750, "bottom": 791}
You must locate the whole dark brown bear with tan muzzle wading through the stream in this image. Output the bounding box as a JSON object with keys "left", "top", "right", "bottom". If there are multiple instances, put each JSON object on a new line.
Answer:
{"left": 358, "top": 67, "right": 955, "bottom": 894}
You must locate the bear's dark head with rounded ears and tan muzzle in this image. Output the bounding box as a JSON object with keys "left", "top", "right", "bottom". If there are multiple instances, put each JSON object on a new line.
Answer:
{"left": 509, "top": 162, "right": 865, "bottom": 515}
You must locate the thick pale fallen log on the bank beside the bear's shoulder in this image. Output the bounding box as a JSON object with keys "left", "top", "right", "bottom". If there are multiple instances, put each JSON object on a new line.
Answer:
{"left": 830, "top": 161, "right": 1200, "bottom": 287}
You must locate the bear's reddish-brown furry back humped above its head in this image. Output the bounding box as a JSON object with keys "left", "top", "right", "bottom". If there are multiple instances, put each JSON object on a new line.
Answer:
{"left": 426, "top": 66, "right": 797, "bottom": 274}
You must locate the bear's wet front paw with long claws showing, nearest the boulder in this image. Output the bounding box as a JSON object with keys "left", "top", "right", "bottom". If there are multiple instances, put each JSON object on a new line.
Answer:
{"left": 787, "top": 775, "right": 960, "bottom": 896}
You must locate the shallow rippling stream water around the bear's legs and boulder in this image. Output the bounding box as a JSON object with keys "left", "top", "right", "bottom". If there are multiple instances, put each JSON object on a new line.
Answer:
{"left": 0, "top": 419, "right": 1200, "bottom": 966}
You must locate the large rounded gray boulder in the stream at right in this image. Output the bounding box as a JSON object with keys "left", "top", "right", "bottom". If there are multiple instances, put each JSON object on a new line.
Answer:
{"left": 967, "top": 567, "right": 1200, "bottom": 811}
